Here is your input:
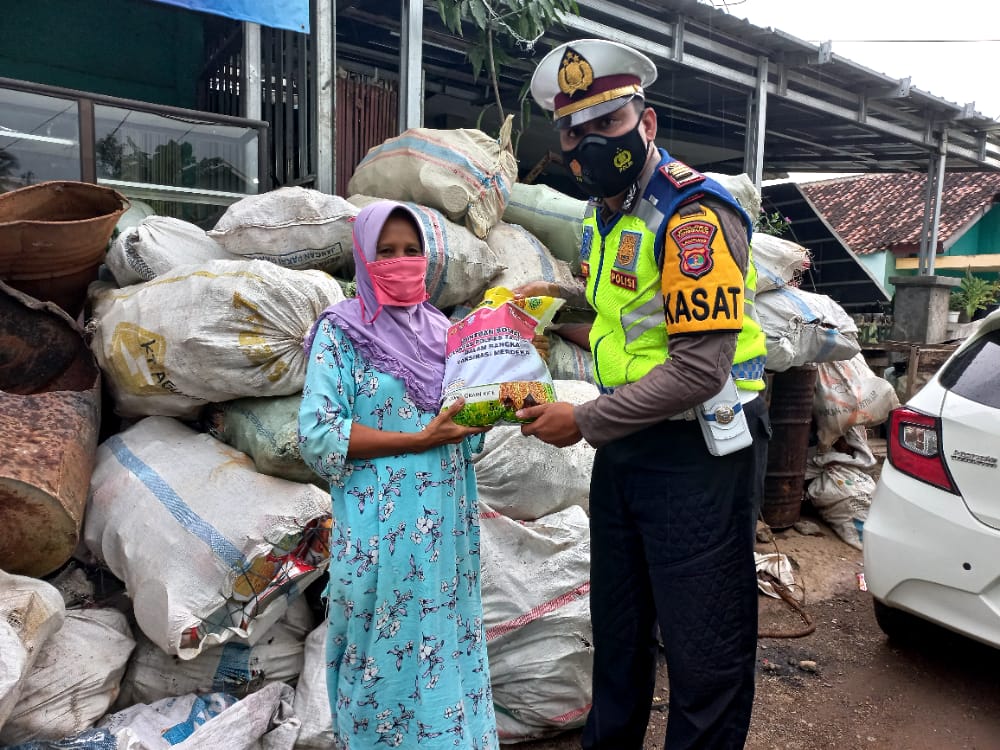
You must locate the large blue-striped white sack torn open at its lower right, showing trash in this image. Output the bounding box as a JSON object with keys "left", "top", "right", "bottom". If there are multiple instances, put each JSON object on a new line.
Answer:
{"left": 84, "top": 417, "right": 330, "bottom": 659}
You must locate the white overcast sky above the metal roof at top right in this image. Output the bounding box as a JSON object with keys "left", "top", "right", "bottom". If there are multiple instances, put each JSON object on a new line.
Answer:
{"left": 728, "top": 0, "right": 1000, "bottom": 119}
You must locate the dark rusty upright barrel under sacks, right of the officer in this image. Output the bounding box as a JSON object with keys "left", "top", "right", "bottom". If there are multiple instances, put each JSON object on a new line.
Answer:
{"left": 761, "top": 365, "right": 816, "bottom": 529}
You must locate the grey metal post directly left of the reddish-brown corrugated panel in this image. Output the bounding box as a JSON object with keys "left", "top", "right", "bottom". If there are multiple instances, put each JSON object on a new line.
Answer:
{"left": 313, "top": 0, "right": 337, "bottom": 195}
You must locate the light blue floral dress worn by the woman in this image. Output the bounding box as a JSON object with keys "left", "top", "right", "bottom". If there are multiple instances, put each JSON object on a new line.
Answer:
{"left": 299, "top": 321, "right": 498, "bottom": 750}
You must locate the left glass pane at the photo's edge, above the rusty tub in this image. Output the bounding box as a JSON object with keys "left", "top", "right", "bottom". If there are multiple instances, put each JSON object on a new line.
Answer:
{"left": 0, "top": 88, "right": 80, "bottom": 193}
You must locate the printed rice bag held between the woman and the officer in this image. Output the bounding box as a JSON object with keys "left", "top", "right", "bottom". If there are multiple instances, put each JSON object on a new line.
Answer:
{"left": 441, "top": 287, "right": 563, "bottom": 427}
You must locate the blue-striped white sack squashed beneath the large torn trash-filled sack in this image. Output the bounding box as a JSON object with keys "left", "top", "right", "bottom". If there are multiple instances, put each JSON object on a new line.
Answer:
{"left": 117, "top": 597, "right": 312, "bottom": 707}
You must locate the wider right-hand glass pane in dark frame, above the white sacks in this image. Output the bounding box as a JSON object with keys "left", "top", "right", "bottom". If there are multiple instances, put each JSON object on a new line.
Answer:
{"left": 94, "top": 104, "right": 258, "bottom": 228}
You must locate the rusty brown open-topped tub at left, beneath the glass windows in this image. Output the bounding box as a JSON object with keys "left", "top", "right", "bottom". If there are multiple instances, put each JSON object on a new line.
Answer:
{"left": 0, "top": 180, "right": 130, "bottom": 317}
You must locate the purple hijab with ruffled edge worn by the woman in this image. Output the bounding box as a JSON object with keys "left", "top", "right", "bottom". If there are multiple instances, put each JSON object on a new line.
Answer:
{"left": 305, "top": 201, "right": 450, "bottom": 412}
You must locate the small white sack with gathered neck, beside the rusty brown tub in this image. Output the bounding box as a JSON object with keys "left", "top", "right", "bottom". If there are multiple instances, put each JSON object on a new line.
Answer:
{"left": 104, "top": 216, "right": 242, "bottom": 286}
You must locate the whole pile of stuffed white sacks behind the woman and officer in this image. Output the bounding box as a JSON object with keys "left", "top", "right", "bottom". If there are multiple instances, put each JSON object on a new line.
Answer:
{"left": 0, "top": 121, "right": 900, "bottom": 750}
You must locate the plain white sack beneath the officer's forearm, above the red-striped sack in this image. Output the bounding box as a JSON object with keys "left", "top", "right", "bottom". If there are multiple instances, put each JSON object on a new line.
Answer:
{"left": 472, "top": 380, "right": 598, "bottom": 521}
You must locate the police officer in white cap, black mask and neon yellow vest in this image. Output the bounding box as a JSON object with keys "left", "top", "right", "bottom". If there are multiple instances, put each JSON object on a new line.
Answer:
{"left": 518, "top": 39, "right": 770, "bottom": 750}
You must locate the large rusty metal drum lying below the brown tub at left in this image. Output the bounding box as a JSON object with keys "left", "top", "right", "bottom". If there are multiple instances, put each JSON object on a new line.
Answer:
{"left": 0, "top": 283, "right": 101, "bottom": 577}
